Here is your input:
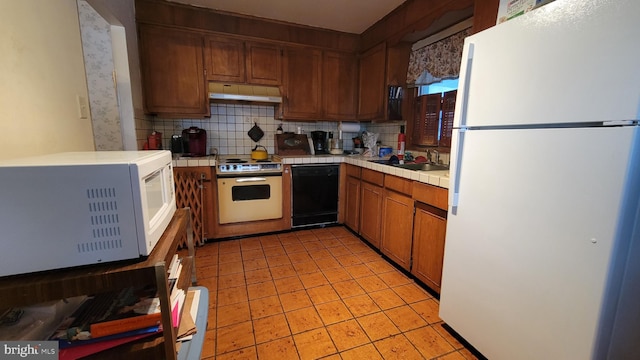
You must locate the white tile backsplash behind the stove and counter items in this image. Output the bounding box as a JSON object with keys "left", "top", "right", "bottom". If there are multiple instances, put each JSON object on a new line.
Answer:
{"left": 153, "top": 104, "right": 448, "bottom": 164}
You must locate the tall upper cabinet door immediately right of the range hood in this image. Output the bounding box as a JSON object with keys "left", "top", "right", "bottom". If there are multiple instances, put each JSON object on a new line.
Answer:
{"left": 284, "top": 48, "right": 322, "bottom": 120}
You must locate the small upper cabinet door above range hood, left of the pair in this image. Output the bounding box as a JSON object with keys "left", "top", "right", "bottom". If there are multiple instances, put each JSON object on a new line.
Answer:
{"left": 204, "top": 36, "right": 246, "bottom": 83}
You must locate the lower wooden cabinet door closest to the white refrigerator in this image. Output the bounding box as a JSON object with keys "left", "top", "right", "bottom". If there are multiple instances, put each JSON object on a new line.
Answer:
{"left": 411, "top": 205, "right": 447, "bottom": 293}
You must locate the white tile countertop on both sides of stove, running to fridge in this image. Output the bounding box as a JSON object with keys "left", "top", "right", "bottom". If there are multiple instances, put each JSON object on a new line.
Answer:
{"left": 173, "top": 155, "right": 449, "bottom": 189}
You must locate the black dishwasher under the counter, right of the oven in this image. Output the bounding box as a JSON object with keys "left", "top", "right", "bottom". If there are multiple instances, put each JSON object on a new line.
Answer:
{"left": 291, "top": 164, "right": 340, "bottom": 227}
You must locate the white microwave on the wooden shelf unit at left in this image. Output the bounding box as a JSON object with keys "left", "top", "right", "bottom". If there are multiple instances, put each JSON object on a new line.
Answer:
{"left": 0, "top": 150, "right": 176, "bottom": 276}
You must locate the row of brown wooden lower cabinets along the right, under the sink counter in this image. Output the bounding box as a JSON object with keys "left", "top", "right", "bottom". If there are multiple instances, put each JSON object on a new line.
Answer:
{"left": 344, "top": 165, "right": 448, "bottom": 293}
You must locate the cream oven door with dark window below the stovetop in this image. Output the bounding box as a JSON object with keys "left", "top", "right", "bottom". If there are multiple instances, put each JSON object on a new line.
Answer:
{"left": 218, "top": 174, "right": 282, "bottom": 224}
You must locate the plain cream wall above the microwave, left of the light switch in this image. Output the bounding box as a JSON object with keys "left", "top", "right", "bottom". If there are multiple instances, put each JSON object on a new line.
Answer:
{"left": 0, "top": 0, "right": 94, "bottom": 159}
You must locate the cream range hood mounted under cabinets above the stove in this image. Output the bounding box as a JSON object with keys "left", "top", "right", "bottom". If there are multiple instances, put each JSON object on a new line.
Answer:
{"left": 209, "top": 82, "right": 282, "bottom": 104}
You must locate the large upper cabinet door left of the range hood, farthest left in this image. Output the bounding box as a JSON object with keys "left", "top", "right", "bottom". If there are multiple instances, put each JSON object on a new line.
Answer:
{"left": 139, "top": 25, "right": 210, "bottom": 117}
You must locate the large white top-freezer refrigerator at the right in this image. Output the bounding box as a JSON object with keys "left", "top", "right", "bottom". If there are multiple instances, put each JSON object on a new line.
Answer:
{"left": 440, "top": 0, "right": 640, "bottom": 360}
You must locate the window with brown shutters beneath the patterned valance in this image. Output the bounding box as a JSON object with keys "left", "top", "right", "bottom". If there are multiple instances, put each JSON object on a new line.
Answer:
{"left": 409, "top": 78, "right": 458, "bottom": 148}
